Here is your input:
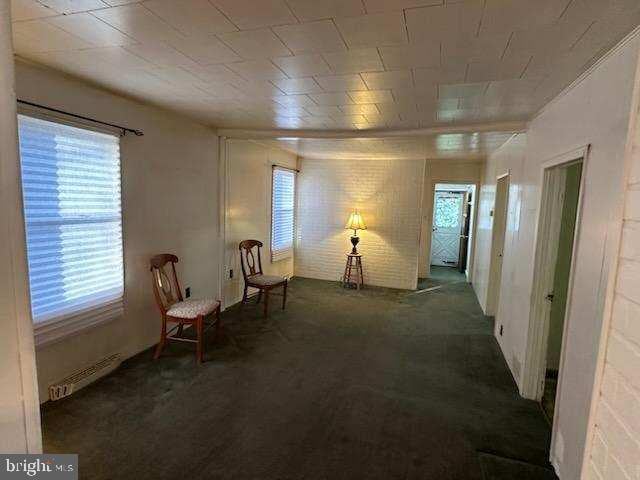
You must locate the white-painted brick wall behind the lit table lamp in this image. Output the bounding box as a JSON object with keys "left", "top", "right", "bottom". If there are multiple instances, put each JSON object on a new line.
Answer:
{"left": 295, "top": 159, "right": 424, "bottom": 289}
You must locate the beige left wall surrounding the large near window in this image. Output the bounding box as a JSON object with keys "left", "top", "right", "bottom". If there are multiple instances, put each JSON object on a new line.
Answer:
{"left": 14, "top": 64, "right": 220, "bottom": 399}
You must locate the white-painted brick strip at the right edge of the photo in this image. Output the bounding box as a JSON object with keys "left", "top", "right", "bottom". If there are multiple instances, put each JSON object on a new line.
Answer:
{"left": 587, "top": 79, "right": 640, "bottom": 480}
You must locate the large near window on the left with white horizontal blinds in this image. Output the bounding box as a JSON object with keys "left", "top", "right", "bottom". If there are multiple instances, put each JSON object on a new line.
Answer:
{"left": 18, "top": 115, "right": 124, "bottom": 344}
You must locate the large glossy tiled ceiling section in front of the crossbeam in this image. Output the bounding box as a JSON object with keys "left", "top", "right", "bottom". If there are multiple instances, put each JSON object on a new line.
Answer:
{"left": 11, "top": 0, "right": 640, "bottom": 135}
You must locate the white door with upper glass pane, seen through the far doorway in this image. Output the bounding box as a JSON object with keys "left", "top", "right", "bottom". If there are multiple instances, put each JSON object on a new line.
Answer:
{"left": 431, "top": 192, "right": 464, "bottom": 267}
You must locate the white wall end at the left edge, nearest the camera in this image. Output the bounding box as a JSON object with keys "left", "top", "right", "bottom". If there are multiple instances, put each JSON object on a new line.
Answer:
{"left": 0, "top": 2, "right": 42, "bottom": 453}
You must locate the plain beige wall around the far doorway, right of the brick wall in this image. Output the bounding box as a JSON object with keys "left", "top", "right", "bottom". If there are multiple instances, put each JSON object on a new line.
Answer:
{"left": 418, "top": 160, "right": 484, "bottom": 278}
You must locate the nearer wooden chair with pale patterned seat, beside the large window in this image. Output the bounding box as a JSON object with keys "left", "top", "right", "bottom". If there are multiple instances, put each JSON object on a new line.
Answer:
{"left": 150, "top": 253, "right": 222, "bottom": 363}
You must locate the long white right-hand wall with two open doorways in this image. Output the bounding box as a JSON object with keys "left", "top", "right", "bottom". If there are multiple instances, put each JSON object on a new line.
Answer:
{"left": 475, "top": 31, "right": 639, "bottom": 479}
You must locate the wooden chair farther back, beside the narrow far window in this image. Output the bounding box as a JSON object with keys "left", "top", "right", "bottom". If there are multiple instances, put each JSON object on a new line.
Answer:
{"left": 239, "top": 240, "right": 287, "bottom": 318}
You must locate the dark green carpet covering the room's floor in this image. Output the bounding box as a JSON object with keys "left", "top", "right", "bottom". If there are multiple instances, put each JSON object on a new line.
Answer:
{"left": 42, "top": 279, "right": 550, "bottom": 480}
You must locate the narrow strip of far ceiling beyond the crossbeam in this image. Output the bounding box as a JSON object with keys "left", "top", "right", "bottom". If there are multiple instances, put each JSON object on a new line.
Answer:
{"left": 255, "top": 132, "right": 512, "bottom": 161}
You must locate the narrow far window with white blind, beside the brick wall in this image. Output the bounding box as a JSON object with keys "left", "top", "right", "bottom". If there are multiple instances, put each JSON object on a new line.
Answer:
{"left": 271, "top": 167, "right": 296, "bottom": 262}
